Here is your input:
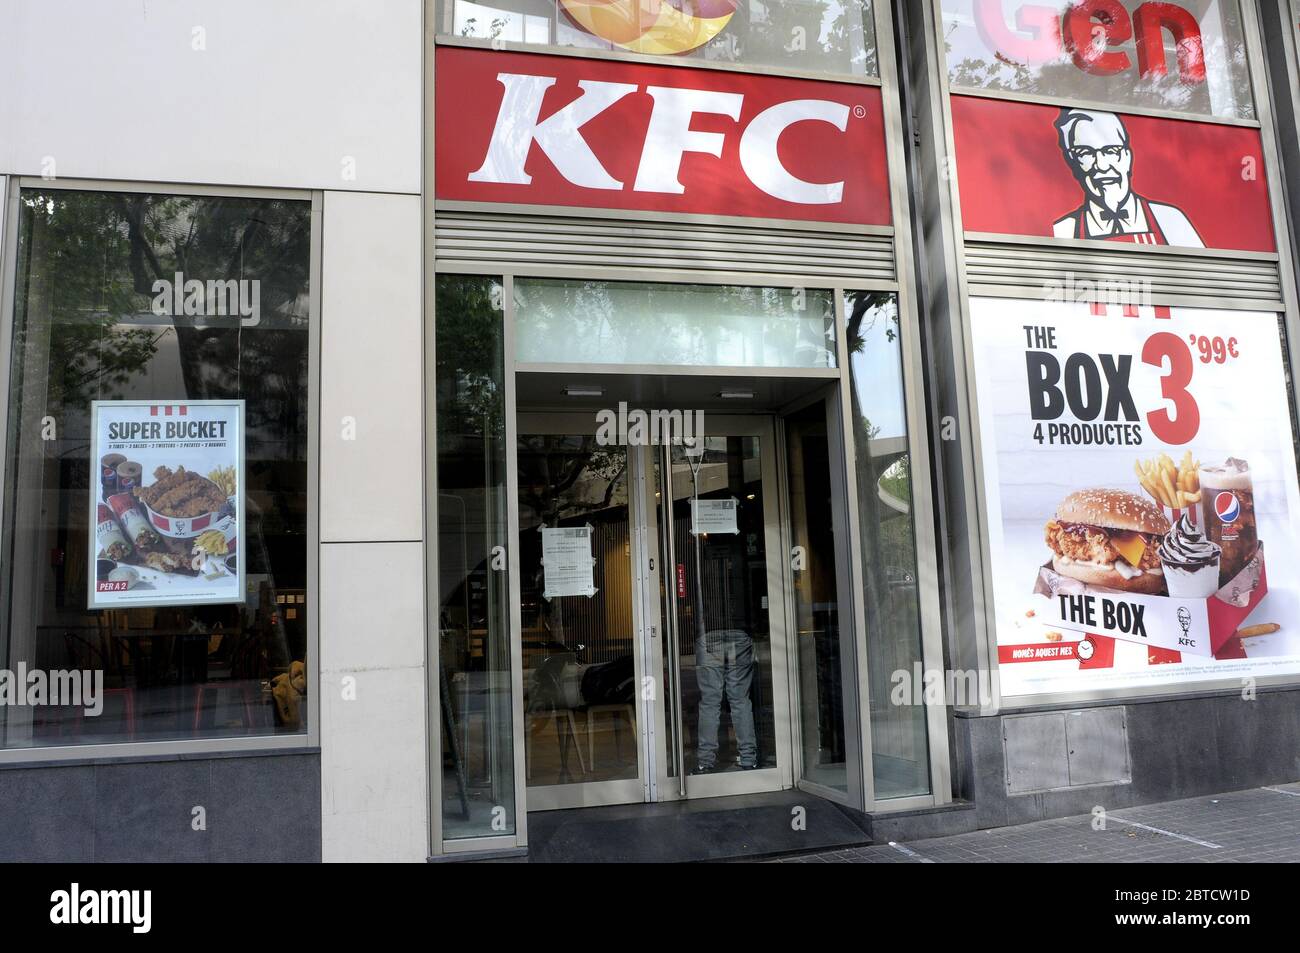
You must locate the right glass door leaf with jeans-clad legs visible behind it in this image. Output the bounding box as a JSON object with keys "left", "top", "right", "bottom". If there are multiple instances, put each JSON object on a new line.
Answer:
{"left": 653, "top": 417, "right": 790, "bottom": 798}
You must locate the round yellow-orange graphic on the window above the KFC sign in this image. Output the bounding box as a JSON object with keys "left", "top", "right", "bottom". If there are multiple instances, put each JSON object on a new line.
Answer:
{"left": 559, "top": 0, "right": 736, "bottom": 53}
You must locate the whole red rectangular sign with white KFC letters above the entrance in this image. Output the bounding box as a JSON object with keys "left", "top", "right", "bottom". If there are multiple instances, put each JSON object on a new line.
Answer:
{"left": 434, "top": 47, "right": 891, "bottom": 225}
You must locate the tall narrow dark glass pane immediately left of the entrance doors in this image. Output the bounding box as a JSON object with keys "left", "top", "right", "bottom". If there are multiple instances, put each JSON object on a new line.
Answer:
{"left": 434, "top": 274, "right": 515, "bottom": 839}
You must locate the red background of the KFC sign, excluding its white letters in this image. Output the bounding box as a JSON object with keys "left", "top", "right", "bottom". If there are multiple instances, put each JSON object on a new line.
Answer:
{"left": 434, "top": 47, "right": 891, "bottom": 225}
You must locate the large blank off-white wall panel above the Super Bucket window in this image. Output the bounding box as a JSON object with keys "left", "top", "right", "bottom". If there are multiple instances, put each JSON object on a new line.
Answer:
{"left": 0, "top": 0, "right": 423, "bottom": 192}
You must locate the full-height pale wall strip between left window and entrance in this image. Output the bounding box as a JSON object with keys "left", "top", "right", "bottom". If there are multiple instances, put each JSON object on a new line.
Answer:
{"left": 320, "top": 192, "right": 428, "bottom": 861}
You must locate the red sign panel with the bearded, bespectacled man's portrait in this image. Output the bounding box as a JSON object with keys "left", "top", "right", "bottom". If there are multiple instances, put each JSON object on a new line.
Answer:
{"left": 952, "top": 96, "right": 1275, "bottom": 252}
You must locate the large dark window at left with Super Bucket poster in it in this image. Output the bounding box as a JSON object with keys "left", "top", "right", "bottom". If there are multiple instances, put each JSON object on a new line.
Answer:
{"left": 0, "top": 189, "right": 315, "bottom": 748}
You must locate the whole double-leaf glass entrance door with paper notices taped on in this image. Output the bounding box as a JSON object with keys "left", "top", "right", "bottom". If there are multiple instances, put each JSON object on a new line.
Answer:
{"left": 516, "top": 413, "right": 790, "bottom": 810}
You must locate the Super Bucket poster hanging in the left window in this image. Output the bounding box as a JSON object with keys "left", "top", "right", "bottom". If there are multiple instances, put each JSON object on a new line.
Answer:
{"left": 88, "top": 400, "right": 244, "bottom": 608}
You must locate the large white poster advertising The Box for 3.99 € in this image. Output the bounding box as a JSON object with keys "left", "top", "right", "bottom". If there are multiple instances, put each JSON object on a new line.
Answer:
{"left": 971, "top": 298, "right": 1300, "bottom": 697}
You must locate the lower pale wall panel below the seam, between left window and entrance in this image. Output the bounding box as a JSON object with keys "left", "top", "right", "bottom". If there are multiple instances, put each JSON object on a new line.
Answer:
{"left": 320, "top": 542, "right": 429, "bottom": 862}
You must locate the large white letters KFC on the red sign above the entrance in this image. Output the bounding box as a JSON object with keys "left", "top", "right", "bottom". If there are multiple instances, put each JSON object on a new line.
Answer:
{"left": 469, "top": 73, "right": 861, "bottom": 205}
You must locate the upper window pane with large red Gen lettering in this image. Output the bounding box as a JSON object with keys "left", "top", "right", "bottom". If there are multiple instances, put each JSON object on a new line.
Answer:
{"left": 943, "top": 0, "right": 1255, "bottom": 118}
